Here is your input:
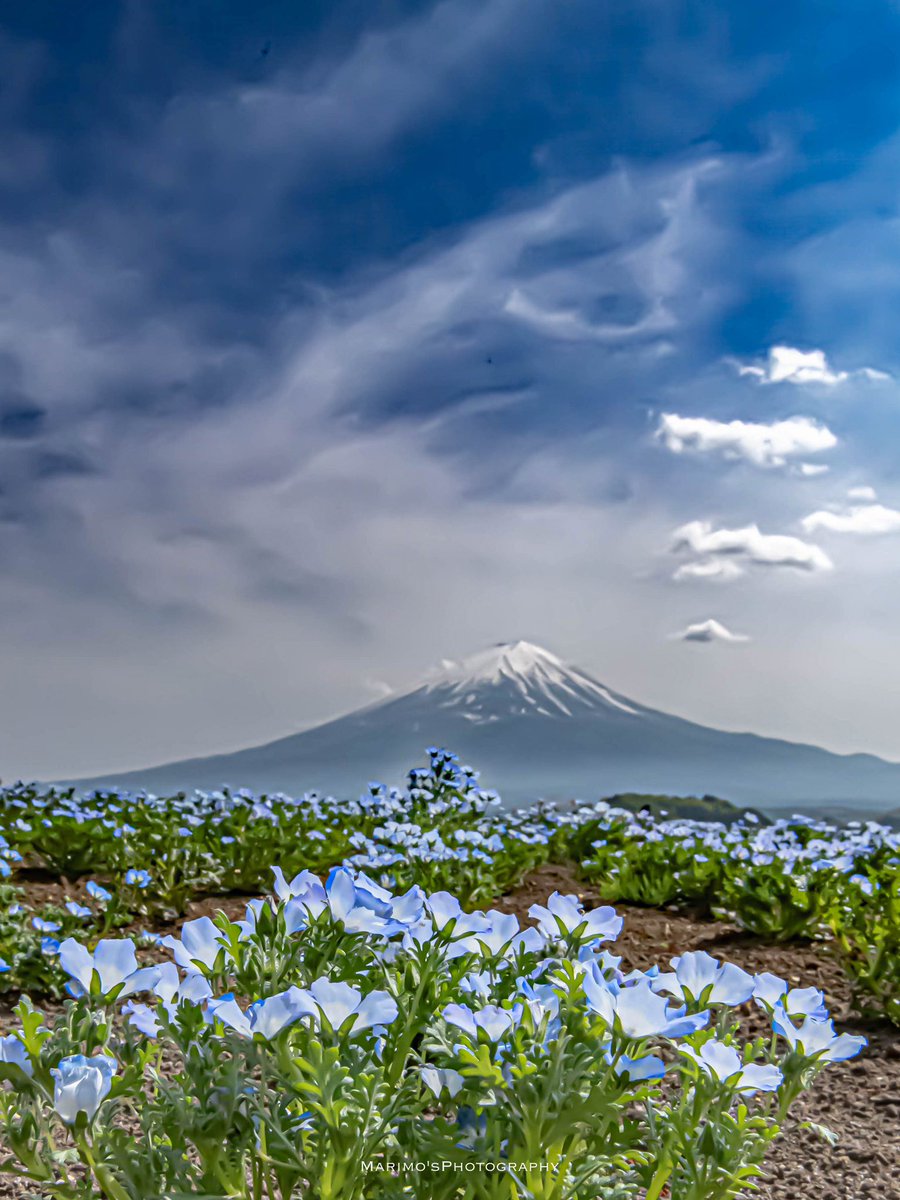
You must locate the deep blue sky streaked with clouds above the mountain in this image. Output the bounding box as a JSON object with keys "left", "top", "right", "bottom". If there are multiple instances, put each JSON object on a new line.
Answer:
{"left": 0, "top": 0, "right": 900, "bottom": 779}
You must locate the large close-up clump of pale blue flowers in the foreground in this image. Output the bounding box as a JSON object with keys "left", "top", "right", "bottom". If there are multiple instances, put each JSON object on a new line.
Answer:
{"left": 0, "top": 868, "right": 864, "bottom": 1200}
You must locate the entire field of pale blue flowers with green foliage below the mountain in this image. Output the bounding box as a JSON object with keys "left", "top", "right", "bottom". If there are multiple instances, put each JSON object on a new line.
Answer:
{"left": 0, "top": 750, "right": 900, "bottom": 1200}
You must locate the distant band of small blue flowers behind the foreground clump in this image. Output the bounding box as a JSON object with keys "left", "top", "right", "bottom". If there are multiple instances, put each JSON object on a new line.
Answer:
{"left": 0, "top": 750, "right": 900, "bottom": 1024}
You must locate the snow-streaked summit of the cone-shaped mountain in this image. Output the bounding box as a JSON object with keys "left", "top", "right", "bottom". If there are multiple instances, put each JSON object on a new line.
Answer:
{"left": 424, "top": 641, "right": 637, "bottom": 720}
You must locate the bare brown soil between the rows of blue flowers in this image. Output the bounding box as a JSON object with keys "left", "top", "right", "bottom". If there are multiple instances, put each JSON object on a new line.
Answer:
{"left": 0, "top": 864, "right": 900, "bottom": 1200}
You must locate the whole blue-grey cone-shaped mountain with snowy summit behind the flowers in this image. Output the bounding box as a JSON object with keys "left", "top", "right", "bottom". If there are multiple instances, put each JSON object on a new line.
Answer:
{"left": 66, "top": 642, "right": 900, "bottom": 810}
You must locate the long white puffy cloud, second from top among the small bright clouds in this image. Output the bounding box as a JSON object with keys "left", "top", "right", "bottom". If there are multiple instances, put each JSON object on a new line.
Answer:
{"left": 656, "top": 413, "right": 838, "bottom": 474}
